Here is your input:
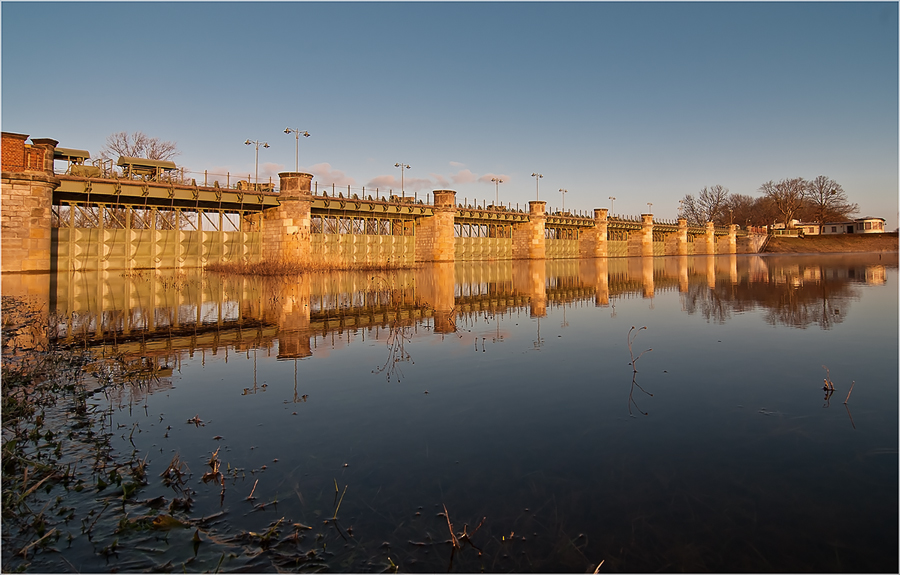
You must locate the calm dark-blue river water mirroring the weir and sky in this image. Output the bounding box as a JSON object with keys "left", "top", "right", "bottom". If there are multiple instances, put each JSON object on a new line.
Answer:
{"left": 3, "top": 254, "right": 898, "bottom": 572}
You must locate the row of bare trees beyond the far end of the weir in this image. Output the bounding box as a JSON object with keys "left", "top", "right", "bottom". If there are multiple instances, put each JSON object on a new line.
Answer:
{"left": 680, "top": 176, "right": 859, "bottom": 231}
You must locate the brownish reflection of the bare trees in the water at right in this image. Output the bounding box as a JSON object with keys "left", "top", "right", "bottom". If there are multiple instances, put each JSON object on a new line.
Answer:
{"left": 682, "top": 265, "right": 865, "bottom": 329}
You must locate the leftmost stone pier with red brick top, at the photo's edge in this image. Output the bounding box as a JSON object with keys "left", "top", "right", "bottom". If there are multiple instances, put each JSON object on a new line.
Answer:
{"left": 0, "top": 132, "right": 60, "bottom": 273}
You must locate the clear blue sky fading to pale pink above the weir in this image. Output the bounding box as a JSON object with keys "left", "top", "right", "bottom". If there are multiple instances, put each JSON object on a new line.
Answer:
{"left": 0, "top": 1, "right": 898, "bottom": 230}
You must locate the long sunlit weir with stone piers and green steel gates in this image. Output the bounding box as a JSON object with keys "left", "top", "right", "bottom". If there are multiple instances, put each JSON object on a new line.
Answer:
{"left": 0, "top": 132, "right": 764, "bottom": 273}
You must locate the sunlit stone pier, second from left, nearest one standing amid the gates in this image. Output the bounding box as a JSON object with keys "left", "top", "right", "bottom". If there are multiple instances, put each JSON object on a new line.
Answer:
{"left": 262, "top": 172, "right": 313, "bottom": 264}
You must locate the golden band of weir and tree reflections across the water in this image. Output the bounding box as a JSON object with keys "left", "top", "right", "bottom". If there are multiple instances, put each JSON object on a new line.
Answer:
{"left": 10, "top": 254, "right": 884, "bottom": 358}
